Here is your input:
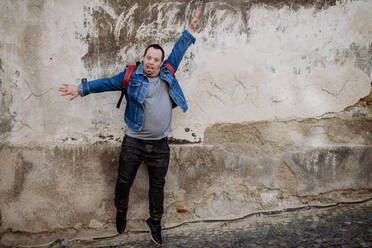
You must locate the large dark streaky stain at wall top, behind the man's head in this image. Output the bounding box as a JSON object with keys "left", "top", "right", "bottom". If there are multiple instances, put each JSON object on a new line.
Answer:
{"left": 77, "top": 0, "right": 337, "bottom": 73}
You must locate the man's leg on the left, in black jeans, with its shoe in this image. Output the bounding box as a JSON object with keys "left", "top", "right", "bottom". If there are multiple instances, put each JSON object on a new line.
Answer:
{"left": 115, "top": 136, "right": 142, "bottom": 233}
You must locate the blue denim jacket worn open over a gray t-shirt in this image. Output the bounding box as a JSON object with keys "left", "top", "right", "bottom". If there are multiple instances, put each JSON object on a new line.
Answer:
{"left": 78, "top": 30, "right": 195, "bottom": 131}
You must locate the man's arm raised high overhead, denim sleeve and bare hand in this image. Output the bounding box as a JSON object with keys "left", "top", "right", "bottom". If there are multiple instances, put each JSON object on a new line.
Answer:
{"left": 164, "top": 10, "right": 200, "bottom": 71}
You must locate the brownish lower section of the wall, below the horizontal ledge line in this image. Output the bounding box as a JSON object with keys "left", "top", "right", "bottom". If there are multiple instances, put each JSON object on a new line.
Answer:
{"left": 0, "top": 144, "right": 372, "bottom": 245}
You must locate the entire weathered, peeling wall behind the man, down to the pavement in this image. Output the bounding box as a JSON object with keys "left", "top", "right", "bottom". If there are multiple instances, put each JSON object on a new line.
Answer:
{"left": 0, "top": 0, "right": 372, "bottom": 245}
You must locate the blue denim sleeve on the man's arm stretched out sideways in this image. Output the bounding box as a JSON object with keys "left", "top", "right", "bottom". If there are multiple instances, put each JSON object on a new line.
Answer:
{"left": 78, "top": 69, "right": 126, "bottom": 96}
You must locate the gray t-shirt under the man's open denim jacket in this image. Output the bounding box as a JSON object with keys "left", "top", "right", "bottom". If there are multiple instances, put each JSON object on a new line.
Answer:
{"left": 126, "top": 77, "right": 172, "bottom": 140}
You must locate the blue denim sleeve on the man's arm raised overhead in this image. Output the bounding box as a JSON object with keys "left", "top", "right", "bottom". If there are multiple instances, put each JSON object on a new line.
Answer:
{"left": 164, "top": 30, "right": 195, "bottom": 71}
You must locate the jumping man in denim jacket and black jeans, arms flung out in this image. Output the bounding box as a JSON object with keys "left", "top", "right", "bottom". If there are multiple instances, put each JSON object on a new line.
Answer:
{"left": 59, "top": 10, "right": 200, "bottom": 245}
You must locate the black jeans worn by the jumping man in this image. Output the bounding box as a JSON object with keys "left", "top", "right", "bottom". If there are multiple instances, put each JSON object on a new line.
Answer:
{"left": 115, "top": 135, "right": 170, "bottom": 220}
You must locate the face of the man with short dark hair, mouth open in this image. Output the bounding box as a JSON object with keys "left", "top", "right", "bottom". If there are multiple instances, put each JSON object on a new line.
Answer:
{"left": 142, "top": 47, "right": 163, "bottom": 77}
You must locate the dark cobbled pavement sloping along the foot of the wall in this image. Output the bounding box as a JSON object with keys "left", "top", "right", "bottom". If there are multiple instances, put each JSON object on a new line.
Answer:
{"left": 67, "top": 199, "right": 372, "bottom": 248}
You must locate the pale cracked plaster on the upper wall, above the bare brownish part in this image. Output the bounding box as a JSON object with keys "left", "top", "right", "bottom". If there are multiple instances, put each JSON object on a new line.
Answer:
{"left": 0, "top": 0, "right": 372, "bottom": 144}
